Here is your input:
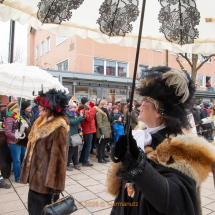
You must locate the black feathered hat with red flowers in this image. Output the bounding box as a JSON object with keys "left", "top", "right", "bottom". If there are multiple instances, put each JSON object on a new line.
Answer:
{"left": 34, "top": 89, "right": 69, "bottom": 115}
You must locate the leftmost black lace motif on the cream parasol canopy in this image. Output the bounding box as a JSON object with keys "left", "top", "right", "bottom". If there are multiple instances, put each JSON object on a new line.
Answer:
{"left": 37, "top": 0, "right": 84, "bottom": 24}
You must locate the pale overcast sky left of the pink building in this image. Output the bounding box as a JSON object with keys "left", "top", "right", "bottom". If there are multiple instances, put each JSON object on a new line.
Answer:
{"left": 0, "top": 21, "right": 28, "bottom": 63}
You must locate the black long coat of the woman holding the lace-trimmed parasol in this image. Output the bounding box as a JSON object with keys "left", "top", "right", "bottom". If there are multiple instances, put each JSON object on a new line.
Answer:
{"left": 110, "top": 128, "right": 200, "bottom": 215}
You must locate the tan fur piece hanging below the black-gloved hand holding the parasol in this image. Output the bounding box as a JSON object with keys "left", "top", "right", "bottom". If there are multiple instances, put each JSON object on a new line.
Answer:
{"left": 106, "top": 163, "right": 121, "bottom": 197}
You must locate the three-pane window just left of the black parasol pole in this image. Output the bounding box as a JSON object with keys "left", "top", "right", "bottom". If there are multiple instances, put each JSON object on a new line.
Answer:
{"left": 93, "top": 58, "right": 128, "bottom": 77}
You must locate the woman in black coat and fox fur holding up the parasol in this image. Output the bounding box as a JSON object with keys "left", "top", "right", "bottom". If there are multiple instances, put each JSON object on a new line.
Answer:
{"left": 107, "top": 67, "right": 212, "bottom": 215}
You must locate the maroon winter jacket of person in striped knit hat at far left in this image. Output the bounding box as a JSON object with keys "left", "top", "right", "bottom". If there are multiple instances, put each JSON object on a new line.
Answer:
{"left": 4, "top": 116, "right": 16, "bottom": 144}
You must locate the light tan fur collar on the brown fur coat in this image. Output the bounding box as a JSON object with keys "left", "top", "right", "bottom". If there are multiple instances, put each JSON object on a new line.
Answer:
{"left": 25, "top": 117, "right": 69, "bottom": 166}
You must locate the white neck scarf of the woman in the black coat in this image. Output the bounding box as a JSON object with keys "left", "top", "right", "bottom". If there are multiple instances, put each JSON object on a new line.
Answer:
{"left": 132, "top": 124, "right": 165, "bottom": 150}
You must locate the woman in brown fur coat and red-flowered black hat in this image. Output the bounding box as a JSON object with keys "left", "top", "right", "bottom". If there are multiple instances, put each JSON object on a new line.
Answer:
{"left": 20, "top": 89, "right": 69, "bottom": 215}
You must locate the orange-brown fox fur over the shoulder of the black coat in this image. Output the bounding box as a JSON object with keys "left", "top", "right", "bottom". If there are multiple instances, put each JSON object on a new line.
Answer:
{"left": 147, "top": 134, "right": 215, "bottom": 187}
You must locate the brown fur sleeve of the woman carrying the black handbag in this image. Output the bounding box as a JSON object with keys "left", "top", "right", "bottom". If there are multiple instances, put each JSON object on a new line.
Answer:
{"left": 45, "top": 127, "right": 68, "bottom": 191}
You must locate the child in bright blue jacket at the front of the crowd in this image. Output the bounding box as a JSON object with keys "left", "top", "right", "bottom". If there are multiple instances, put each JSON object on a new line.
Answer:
{"left": 113, "top": 114, "right": 124, "bottom": 143}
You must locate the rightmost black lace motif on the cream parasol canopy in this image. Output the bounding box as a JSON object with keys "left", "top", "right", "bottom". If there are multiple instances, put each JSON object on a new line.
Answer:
{"left": 158, "top": 0, "right": 200, "bottom": 45}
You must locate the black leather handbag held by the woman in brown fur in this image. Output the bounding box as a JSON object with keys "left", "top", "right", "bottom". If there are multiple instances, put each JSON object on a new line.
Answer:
{"left": 42, "top": 193, "right": 77, "bottom": 215}
